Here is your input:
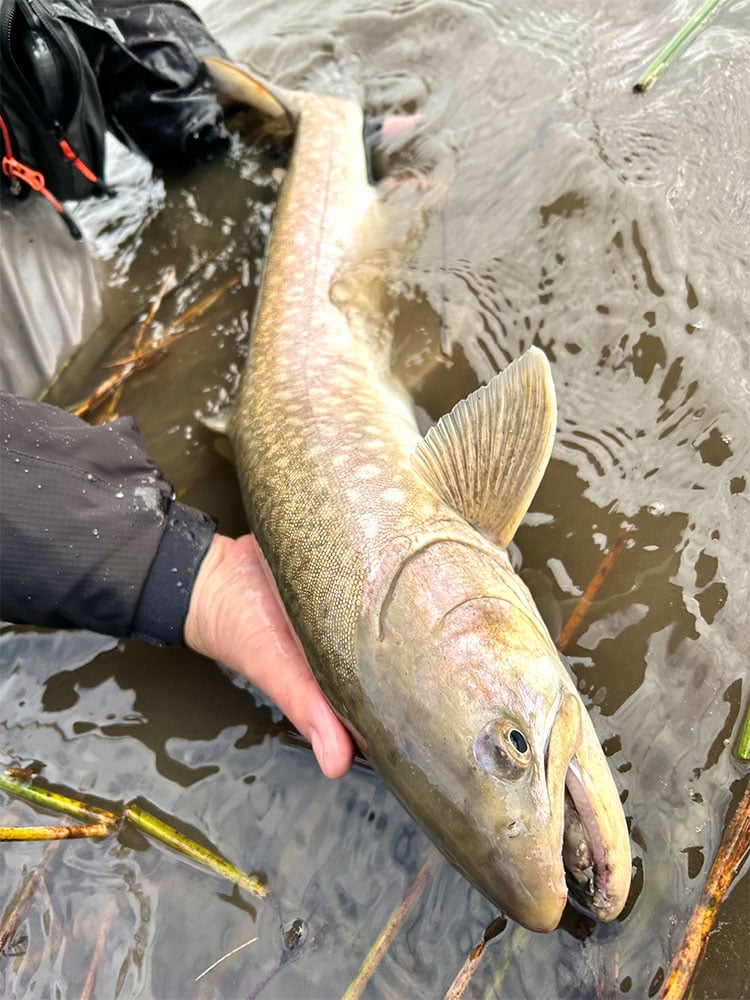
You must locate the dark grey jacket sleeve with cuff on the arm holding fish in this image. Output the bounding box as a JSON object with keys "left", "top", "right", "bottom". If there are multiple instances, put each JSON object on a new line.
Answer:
{"left": 0, "top": 394, "right": 215, "bottom": 645}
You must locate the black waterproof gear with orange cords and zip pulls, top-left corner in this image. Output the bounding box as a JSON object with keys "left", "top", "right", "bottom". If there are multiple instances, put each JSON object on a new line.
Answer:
{"left": 0, "top": 0, "right": 231, "bottom": 211}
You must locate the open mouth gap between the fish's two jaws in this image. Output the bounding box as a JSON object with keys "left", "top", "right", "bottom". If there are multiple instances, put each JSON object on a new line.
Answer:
{"left": 562, "top": 762, "right": 612, "bottom": 920}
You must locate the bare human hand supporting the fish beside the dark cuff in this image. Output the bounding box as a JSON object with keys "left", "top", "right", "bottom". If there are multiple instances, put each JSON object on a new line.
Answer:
{"left": 184, "top": 534, "right": 354, "bottom": 778}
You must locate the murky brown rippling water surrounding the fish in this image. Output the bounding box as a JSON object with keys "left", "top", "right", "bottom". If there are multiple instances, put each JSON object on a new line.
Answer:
{"left": 0, "top": 0, "right": 750, "bottom": 998}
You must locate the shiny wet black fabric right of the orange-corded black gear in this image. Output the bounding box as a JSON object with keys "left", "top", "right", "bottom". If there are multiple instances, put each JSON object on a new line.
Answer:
{"left": 91, "top": 0, "right": 230, "bottom": 167}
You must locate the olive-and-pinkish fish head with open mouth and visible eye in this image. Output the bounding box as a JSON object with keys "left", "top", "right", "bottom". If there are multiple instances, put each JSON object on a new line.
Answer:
{"left": 365, "top": 543, "right": 630, "bottom": 931}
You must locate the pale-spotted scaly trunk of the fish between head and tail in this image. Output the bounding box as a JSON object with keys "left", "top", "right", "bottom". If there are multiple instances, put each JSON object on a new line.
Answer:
{"left": 231, "top": 98, "right": 450, "bottom": 707}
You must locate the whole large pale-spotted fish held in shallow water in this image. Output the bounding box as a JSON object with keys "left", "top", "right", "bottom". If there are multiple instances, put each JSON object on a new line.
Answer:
{"left": 206, "top": 57, "right": 631, "bottom": 932}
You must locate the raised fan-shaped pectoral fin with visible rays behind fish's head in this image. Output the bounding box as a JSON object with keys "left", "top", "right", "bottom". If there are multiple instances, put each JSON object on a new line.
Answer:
{"left": 413, "top": 347, "right": 557, "bottom": 548}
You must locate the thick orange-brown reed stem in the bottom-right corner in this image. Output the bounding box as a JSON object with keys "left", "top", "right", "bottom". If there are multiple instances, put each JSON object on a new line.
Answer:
{"left": 659, "top": 786, "right": 750, "bottom": 1000}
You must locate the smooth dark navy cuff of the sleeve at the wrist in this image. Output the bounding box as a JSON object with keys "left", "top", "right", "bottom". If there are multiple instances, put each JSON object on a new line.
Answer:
{"left": 130, "top": 501, "right": 216, "bottom": 646}
